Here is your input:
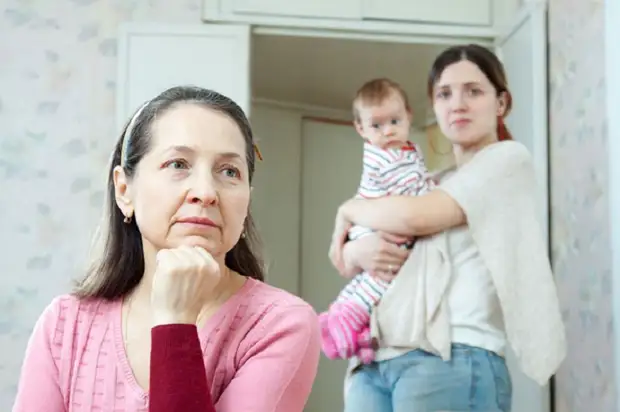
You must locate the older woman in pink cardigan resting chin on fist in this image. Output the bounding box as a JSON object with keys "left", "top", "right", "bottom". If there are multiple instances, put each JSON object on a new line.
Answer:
{"left": 14, "top": 87, "right": 320, "bottom": 412}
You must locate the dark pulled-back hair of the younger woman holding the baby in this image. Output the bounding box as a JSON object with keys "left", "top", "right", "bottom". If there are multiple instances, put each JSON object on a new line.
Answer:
{"left": 427, "top": 44, "right": 512, "bottom": 140}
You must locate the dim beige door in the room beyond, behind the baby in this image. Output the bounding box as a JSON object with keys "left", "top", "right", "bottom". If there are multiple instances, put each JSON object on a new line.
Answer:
{"left": 300, "top": 121, "right": 363, "bottom": 412}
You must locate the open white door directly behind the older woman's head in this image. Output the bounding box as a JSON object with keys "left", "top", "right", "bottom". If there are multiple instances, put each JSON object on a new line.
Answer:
{"left": 116, "top": 23, "right": 251, "bottom": 130}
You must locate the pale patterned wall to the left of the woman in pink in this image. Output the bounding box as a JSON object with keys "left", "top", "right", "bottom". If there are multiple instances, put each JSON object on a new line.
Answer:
{"left": 0, "top": 0, "right": 200, "bottom": 411}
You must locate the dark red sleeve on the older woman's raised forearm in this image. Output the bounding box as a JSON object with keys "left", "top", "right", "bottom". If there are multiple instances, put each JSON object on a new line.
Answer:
{"left": 149, "top": 324, "right": 215, "bottom": 412}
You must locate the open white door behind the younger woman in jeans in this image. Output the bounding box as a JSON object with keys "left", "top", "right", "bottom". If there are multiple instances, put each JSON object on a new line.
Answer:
{"left": 497, "top": 4, "right": 551, "bottom": 412}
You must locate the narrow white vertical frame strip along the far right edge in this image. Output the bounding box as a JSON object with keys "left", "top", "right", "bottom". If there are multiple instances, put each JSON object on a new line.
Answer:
{"left": 604, "top": 0, "right": 620, "bottom": 397}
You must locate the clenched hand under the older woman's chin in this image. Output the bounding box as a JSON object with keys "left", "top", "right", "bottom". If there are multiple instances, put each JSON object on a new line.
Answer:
{"left": 151, "top": 246, "right": 221, "bottom": 325}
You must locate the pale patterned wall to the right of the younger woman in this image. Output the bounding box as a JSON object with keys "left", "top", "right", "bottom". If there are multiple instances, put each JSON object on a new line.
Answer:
{"left": 549, "top": 0, "right": 616, "bottom": 412}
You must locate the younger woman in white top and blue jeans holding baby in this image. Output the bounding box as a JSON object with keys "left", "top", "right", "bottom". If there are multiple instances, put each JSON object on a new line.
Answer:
{"left": 331, "top": 45, "right": 566, "bottom": 412}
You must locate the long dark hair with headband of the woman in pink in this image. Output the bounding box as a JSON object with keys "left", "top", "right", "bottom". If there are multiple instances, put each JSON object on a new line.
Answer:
{"left": 73, "top": 86, "right": 264, "bottom": 300}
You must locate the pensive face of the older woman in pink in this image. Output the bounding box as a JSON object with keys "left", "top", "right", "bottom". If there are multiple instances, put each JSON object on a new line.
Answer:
{"left": 115, "top": 103, "right": 250, "bottom": 257}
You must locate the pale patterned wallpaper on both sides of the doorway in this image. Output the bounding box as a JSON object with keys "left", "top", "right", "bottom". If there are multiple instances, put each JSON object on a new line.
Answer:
{"left": 0, "top": 0, "right": 615, "bottom": 412}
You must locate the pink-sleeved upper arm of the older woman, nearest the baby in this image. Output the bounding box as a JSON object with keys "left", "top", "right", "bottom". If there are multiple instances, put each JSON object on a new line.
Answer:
{"left": 217, "top": 303, "right": 320, "bottom": 412}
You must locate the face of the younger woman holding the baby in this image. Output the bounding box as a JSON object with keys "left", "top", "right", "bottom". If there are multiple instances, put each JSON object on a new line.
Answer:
{"left": 433, "top": 60, "right": 506, "bottom": 147}
